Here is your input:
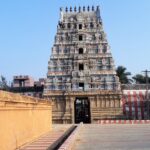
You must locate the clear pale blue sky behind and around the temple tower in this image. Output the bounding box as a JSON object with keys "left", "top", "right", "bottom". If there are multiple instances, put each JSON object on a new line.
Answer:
{"left": 0, "top": 0, "right": 150, "bottom": 81}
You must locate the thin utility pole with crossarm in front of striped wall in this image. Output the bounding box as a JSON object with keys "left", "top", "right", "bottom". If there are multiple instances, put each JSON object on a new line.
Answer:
{"left": 142, "top": 70, "right": 150, "bottom": 119}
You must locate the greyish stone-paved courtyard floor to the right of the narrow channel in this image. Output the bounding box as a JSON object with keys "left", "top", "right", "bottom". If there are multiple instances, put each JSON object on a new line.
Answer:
{"left": 73, "top": 124, "right": 150, "bottom": 150}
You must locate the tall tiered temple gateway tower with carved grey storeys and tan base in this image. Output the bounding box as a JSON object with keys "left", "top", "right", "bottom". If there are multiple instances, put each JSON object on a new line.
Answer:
{"left": 44, "top": 6, "right": 122, "bottom": 123}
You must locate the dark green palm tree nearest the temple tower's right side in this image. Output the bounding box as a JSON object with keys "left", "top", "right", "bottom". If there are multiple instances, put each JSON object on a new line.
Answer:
{"left": 116, "top": 66, "right": 132, "bottom": 84}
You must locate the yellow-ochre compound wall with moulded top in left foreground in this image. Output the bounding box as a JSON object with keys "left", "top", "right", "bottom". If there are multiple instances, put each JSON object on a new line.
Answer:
{"left": 0, "top": 91, "right": 52, "bottom": 150}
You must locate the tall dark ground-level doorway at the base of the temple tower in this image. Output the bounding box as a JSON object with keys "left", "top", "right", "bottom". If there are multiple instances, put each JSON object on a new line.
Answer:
{"left": 75, "top": 97, "right": 91, "bottom": 123}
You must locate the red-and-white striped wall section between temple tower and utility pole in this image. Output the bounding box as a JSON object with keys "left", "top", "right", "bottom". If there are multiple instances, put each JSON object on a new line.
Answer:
{"left": 122, "top": 90, "right": 150, "bottom": 120}
